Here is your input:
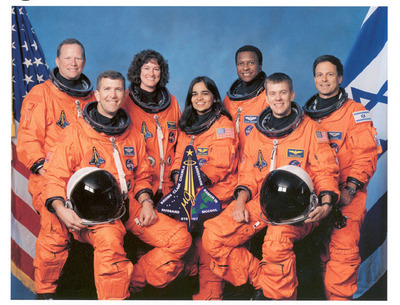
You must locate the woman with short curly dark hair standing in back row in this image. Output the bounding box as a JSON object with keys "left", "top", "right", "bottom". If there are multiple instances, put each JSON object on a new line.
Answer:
{"left": 123, "top": 50, "right": 181, "bottom": 203}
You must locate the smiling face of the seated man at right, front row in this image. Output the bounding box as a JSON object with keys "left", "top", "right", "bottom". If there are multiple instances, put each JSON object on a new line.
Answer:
{"left": 265, "top": 81, "right": 294, "bottom": 118}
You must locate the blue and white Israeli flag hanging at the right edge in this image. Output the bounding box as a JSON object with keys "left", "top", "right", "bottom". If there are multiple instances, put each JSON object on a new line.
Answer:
{"left": 342, "top": 7, "right": 388, "bottom": 299}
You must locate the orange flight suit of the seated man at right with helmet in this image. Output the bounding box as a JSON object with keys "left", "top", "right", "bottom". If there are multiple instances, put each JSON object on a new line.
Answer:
{"left": 203, "top": 103, "right": 339, "bottom": 299}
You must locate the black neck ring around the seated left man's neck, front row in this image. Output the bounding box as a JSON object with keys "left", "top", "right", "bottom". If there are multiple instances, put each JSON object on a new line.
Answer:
{"left": 83, "top": 101, "right": 131, "bottom": 136}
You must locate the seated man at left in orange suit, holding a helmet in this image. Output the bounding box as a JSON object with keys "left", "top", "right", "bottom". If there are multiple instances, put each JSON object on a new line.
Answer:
{"left": 41, "top": 71, "right": 191, "bottom": 299}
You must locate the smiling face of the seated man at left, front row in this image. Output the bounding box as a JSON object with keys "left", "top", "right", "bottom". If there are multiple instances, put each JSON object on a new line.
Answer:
{"left": 94, "top": 78, "right": 125, "bottom": 119}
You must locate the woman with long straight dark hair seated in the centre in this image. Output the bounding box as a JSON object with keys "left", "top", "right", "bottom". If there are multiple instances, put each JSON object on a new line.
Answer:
{"left": 172, "top": 76, "right": 238, "bottom": 300}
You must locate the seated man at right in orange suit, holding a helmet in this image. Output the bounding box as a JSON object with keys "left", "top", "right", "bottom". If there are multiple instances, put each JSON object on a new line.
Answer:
{"left": 203, "top": 73, "right": 339, "bottom": 299}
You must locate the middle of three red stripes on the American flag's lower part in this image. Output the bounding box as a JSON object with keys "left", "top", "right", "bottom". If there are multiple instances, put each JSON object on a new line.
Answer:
{"left": 11, "top": 190, "right": 40, "bottom": 237}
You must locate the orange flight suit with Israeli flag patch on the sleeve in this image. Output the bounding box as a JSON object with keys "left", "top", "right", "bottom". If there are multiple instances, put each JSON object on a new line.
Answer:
{"left": 304, "top": 96, "right": 381, "bottom": 300}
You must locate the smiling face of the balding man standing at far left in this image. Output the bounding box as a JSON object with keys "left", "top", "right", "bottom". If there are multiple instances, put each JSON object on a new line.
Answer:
{"left": 56, "top": 44, "right": 86, "bottom": 80}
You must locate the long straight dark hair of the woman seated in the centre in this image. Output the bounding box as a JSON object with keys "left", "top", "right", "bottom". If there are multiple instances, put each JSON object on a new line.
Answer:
{"left": 178, "top": 76, "right": 232, "bottom": 130}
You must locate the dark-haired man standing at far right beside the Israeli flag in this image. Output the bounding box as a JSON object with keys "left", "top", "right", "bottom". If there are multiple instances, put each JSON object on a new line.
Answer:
{"left": 304, "top": 55, "right": 381, "bottom": 300}
